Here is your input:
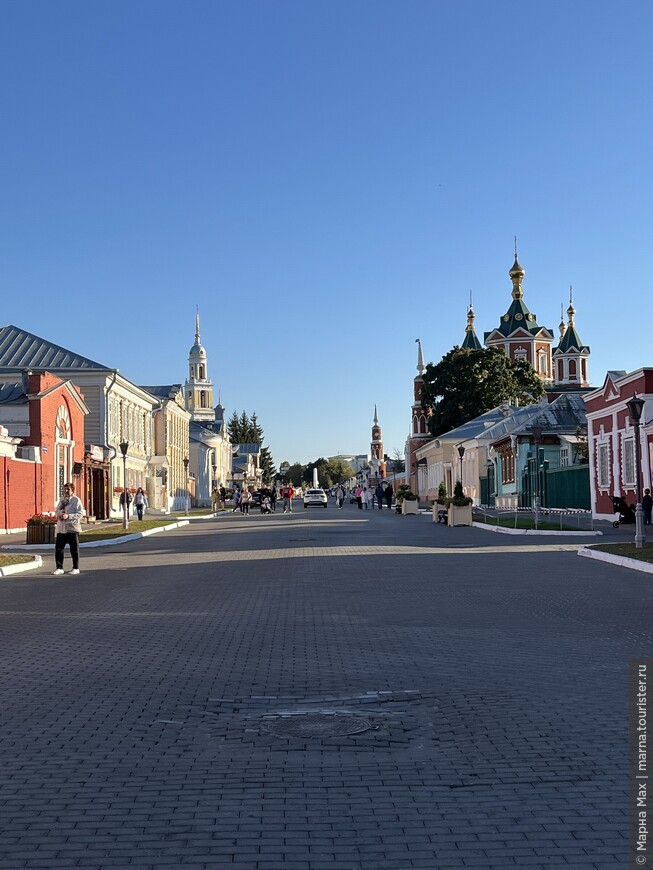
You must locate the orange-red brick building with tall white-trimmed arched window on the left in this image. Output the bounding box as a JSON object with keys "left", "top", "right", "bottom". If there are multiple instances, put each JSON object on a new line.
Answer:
{"left": 0, "top": 372, "right": 88, "bottom": 531}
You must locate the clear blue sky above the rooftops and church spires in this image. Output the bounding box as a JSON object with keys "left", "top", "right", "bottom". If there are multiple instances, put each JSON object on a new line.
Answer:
{"left": 0, "top": 0, "right": 653, "bottom": 465}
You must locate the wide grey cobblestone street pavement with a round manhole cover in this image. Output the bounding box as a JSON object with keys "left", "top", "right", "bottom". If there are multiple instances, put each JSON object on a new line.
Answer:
{"left": 0, "top": 505, "right": 653, "bottom": 870}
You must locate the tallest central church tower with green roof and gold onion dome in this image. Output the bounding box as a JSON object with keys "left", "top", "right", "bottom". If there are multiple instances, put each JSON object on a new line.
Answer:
{"left": 484, "top": 240, "right": 554, "bottom": 385}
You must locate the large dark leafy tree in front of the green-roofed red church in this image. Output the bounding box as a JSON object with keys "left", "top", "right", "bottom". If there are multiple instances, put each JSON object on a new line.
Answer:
{"left": 422, "top": 347, "right": 544, "bottom": 436}
